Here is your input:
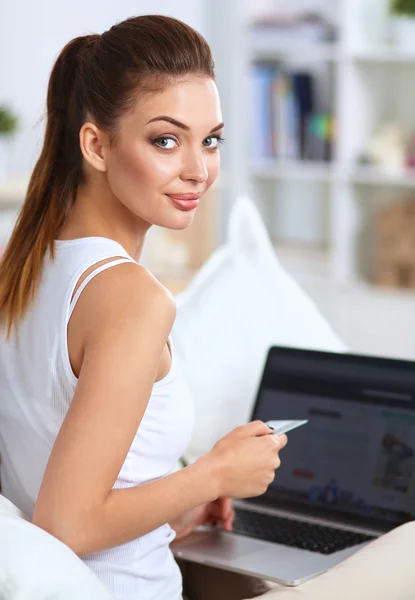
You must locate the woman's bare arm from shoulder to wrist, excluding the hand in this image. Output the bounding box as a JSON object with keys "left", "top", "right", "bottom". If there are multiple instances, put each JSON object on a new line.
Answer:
{"left": 33, "top": 264, "right": 218, "bottom": 555}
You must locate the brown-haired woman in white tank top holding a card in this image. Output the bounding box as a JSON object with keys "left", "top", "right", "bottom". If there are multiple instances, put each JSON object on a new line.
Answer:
{"left": 0, "top": 16, "right": 287, "bottom": 600}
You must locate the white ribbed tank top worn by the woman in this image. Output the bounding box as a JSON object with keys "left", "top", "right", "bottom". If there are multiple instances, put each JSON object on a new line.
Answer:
{"left": 0, "top": 237, "right": 194, "bottom": 600}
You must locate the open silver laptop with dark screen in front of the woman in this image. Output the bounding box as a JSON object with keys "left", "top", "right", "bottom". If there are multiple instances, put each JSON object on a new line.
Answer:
{"left": 171, "top": 347, "right": 415, "bottom": 586}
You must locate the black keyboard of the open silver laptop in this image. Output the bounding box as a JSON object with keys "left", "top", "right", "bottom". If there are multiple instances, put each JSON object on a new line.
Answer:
{"left": 233, "top": 508, "right": 373, "bottom": 554}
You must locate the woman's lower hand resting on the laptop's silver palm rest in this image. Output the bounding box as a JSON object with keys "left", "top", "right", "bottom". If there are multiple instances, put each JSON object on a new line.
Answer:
{"left": 170, "top": 498, "right": 235, "bottom": 540}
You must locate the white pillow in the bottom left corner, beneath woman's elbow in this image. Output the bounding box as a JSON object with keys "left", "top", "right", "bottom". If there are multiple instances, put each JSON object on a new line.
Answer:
{"left": 0, "top": 495, "right": 112, "bottom": 600}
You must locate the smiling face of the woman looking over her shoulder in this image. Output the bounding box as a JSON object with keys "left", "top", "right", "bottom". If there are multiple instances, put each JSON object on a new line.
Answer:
{"left": 107, "top": 76, "right": 223, "bottom": 229}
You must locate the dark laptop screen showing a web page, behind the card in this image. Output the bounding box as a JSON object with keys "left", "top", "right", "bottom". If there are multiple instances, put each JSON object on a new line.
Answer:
{"left": 252, "top": 347, "right": 415, "bottom": 530}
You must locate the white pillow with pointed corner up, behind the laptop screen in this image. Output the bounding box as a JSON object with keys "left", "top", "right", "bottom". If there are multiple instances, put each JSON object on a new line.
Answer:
{"left": 172, "top": 198, "right": 345, "bottom": 460}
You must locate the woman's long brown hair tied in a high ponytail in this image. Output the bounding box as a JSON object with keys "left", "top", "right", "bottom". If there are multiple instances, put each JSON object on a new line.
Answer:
{"left": 0, "top": 15, "right": 214, "bottom": 336}
